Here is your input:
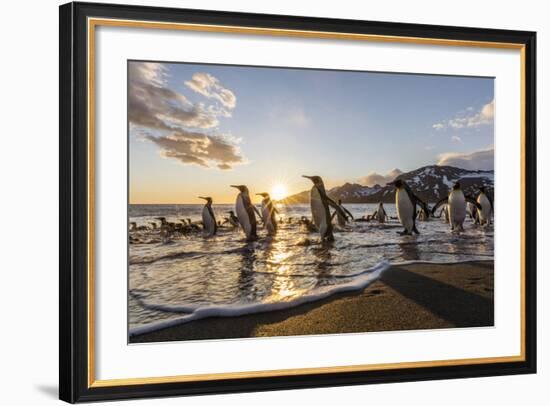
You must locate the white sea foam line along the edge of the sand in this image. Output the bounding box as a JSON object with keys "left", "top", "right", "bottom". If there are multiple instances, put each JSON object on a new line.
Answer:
{"left": 129, "top": 261, "right": 390, "bottom": 337}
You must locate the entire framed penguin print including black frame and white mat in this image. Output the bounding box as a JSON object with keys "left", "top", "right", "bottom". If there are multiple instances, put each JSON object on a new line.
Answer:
{"left": 60, "top": 3, "right": 536, "bottom": 402}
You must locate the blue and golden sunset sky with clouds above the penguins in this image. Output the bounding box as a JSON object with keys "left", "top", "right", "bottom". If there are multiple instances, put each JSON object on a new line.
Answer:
{"left": 128, "top": 61, "right": 494, "bottom": 204}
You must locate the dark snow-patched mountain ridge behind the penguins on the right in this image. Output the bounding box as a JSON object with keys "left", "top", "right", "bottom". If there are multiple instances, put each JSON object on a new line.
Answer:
{"left": 281, "top": 165, "right": 494, "bottom": 204}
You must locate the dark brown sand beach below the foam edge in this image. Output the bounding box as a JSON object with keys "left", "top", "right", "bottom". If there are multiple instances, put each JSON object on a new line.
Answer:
{"left": 130, "top": 261, "right": 494, "bottom": 343}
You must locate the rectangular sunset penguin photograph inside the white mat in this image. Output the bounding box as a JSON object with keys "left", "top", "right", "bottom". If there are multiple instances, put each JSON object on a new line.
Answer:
{"left": 127, "top": 60, "right": 498, "bottom": 344}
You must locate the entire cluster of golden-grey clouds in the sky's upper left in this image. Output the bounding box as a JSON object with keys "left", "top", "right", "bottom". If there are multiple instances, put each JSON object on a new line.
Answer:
{"left": 128, "top": 62, "right": 245, "bottom": 170}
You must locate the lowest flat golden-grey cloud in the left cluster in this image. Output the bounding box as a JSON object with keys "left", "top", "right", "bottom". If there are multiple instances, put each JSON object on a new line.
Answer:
{"left": 144, "top": 130, "right": 244, "bottom": 170}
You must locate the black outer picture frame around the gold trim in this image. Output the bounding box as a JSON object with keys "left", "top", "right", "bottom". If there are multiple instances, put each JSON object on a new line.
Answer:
{"left": 59, "top": 3, "right": 537, "bottom": 403}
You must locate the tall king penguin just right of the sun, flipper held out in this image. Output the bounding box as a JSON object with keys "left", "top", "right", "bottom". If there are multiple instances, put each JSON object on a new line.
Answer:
{"left": 302, "top": 175, "right": 347, "bottom": 241}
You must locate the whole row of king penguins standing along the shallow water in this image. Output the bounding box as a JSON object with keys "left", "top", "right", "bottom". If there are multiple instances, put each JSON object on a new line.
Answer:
{"left": 129, "top": 175, "right": 493, "bottom": 242}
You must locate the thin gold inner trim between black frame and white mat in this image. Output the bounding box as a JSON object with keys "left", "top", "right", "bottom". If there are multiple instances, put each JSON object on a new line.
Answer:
{"left": 87, "top": 18, "right": 526, "bottom": 388}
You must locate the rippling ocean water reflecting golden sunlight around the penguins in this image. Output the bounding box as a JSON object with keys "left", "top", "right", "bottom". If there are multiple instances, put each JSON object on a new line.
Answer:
{"left": 129, "top": 204, "right": 494, "bottom": 335}
